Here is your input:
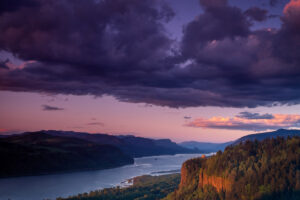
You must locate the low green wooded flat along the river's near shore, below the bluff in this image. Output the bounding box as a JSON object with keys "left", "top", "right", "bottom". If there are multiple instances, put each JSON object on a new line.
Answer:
{"left": 57, "top": 174, "right": 180, "bottom": 200}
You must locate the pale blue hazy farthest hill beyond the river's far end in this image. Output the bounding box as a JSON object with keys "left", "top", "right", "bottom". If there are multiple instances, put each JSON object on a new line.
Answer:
{"left": 179, "top": 141, "right": 233, "bottom": 153}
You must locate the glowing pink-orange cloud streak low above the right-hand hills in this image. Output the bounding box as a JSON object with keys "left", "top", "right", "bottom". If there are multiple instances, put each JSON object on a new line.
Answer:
{"left": 186, "top": 112, "right": 300, "bottom": 131}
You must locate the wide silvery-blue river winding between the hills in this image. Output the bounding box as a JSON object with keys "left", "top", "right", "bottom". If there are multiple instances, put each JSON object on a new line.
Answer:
{"left": 0, "top": 154, "right": 213, "bottom": 200}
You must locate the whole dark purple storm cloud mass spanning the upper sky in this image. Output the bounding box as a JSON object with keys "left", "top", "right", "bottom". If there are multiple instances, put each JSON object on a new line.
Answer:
{"left": 0, "top": 0, "right": 300, "bottom": 107}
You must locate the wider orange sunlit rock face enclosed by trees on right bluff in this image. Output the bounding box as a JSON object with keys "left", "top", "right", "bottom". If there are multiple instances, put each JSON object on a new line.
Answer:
{"left": 198, "top": 171, "right": 232, "bottom": 192}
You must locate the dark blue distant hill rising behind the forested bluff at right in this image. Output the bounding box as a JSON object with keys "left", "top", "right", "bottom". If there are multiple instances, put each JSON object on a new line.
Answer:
{"left": 233, "top": 129, "right": 300, "bottom": 145}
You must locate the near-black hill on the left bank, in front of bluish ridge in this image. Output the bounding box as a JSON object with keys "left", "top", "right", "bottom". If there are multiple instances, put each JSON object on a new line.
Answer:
{"left": 0, "top": 132, "right": 134, "bottom": 177}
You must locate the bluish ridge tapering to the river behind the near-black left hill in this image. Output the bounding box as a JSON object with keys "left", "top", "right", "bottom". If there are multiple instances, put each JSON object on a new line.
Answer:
{"left": 42, "top": 130, "right": 200, "bottom": 157}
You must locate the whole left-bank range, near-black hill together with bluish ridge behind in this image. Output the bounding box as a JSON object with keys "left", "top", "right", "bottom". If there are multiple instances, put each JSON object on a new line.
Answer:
{"left": 0, "top": 131, "right": 199, "bottom": 178}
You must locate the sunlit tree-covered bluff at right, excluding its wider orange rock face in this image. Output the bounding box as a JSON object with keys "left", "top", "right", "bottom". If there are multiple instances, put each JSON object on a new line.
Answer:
{"left": 166, "top": 137, "right": 300, "bottom": 200}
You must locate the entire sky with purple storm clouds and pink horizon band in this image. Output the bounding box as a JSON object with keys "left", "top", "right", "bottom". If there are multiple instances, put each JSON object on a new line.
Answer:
{"left": 0, "top": 0, "right": 300, "bottom": 142}
